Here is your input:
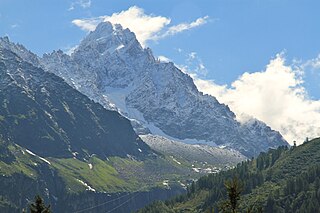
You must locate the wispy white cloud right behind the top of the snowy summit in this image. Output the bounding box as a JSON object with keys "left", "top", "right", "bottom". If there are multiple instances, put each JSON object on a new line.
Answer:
{"left": 72, "top": 6, "right": 209, "bottom": 46}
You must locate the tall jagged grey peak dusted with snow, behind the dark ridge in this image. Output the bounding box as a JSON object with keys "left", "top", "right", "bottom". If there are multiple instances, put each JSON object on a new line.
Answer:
{"left": 0, "top": 22, "right": 288, "bottom": 157}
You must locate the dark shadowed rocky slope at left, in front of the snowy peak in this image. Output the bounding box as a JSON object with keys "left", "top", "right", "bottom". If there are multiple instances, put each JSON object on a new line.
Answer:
{"left": 0, "top": 47, "right": 150, "bottom": 157}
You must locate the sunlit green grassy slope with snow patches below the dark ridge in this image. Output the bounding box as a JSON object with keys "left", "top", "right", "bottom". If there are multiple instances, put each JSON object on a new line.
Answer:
{"left": 0, "top": 140, "right": 198, "bottom": 193}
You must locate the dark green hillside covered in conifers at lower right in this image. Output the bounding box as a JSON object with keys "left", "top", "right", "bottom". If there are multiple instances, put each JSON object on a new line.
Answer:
{"left": 140, "top": 138, "right": 320, "bottom": 213}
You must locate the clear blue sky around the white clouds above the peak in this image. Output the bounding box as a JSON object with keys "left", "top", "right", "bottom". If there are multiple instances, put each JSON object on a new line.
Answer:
{"left": 0, "top": 0, "right": 320, "bottom": 95}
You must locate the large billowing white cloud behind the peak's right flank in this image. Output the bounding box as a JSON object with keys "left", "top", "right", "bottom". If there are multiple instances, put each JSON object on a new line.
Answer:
{"left": 192, "top": 54, "right": 320, "bottom": 144}
